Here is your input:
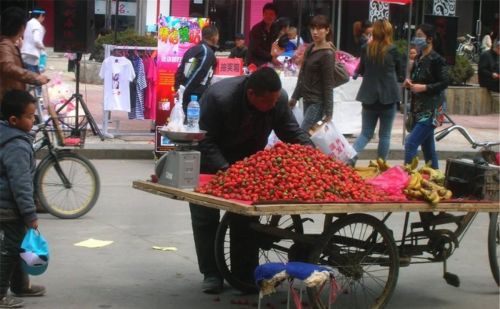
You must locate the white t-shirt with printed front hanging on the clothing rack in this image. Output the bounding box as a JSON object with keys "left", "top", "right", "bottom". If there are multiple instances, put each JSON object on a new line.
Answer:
{"left": 99, "top": 56, "right": 135, "bottom": 112}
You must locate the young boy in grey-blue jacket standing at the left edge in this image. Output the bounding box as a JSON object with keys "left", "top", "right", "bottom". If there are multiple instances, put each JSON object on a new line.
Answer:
{"left": 0, "top": 90, "right": 45, "bottom": 308}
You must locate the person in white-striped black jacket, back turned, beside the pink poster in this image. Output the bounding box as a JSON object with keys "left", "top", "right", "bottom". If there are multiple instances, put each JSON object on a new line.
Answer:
{"left": 175, "top": 26, "right": 219, "bottom": 113}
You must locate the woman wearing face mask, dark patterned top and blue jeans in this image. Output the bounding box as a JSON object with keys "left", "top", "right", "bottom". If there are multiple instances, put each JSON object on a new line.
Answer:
{"left": 404, "top": 24, "right": 448, "bottom": 169}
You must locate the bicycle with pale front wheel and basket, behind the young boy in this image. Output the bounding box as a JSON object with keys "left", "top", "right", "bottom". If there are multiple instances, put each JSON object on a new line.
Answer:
{"left": 33, "top": 95, "right": 101, "bottom": 219}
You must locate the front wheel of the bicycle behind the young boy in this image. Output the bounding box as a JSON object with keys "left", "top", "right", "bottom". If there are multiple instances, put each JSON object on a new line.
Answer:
{"left": 35, "top": 152, "right": 101, "bottom": 219}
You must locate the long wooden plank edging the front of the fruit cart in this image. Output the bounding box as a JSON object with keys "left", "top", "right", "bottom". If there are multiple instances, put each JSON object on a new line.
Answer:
{"left": 133, "top": 181, "right": 500, "bottom": 216}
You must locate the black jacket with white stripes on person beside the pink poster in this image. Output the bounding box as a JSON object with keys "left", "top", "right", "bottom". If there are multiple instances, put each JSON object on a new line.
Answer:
{"left": 175, "top": 41, "right": 217, "bottom": 112}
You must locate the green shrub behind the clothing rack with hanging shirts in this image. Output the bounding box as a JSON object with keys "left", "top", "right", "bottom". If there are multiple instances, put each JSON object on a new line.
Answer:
{"left": 94, "top": 29, "right": 158, "bottom": 61}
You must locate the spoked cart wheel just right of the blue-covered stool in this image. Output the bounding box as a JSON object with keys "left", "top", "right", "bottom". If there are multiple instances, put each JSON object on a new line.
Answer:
{"left": 307, "top": 214, "right": 399, "bottom": 309}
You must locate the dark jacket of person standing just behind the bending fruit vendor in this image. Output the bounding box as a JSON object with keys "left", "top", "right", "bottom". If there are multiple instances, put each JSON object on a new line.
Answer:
{"left": 247, "top": 21, "right": 279, "bottom": 67}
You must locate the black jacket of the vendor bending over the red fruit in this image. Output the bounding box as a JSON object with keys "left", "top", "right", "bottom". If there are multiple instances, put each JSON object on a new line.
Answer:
{"left": 197, "top": 76, "right": 314, "bottom": 174}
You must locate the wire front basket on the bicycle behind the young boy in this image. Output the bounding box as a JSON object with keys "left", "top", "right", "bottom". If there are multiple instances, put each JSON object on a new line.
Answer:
{"left": 50, "top": 115, "right": 88, "bottom": 148}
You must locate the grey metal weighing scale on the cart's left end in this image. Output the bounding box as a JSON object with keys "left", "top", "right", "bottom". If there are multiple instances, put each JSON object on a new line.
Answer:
{"left": 155, "top": 130, "right": 206, "bottom": 189}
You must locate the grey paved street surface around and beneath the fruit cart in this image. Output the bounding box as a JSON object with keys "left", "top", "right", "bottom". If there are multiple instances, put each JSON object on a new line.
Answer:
{"left": 25, "top": 160, "right": 499, "bottom": 309}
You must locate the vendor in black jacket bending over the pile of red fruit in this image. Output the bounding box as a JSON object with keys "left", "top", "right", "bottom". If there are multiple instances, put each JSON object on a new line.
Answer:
{"left": 189, "top": 68, "right": 314, "bottom": 293}
